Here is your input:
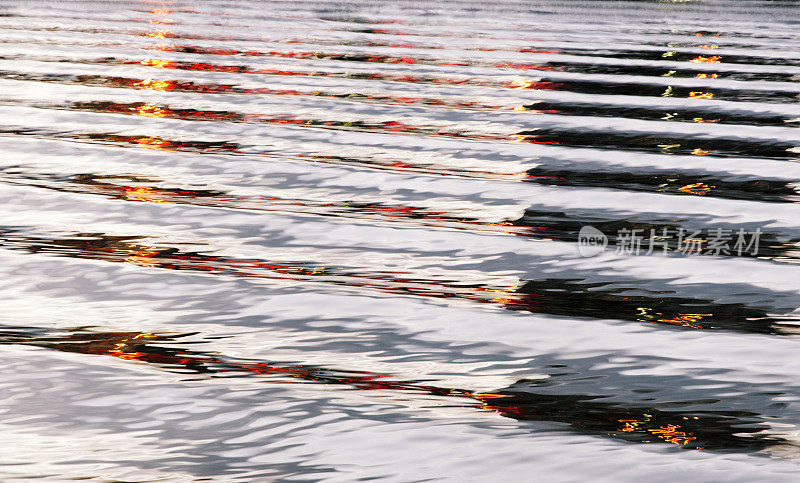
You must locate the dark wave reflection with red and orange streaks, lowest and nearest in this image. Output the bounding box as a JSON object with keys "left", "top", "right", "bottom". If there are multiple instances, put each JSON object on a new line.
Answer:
{"left": 0, "top": 329, "right": 785, "bottom": 451}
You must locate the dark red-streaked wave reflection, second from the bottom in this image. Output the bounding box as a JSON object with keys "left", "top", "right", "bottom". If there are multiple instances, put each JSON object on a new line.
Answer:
{"left": 0, "top": 229, "right": 780, "bottom": 333}
